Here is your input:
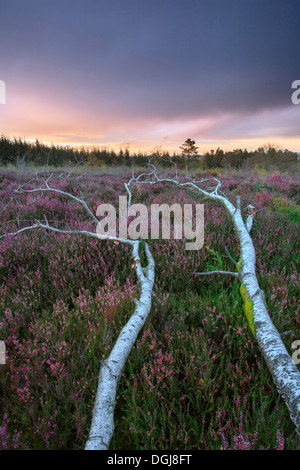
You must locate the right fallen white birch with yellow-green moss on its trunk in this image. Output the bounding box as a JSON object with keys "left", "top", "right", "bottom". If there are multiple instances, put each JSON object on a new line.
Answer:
{"left": 133, "top": 162, "right": 300, "bottom": 435}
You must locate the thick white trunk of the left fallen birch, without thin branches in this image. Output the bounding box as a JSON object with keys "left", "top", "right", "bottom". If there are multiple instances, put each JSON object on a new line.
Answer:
{"left": 85, "top": 244, "right": 154, "bottom": 450}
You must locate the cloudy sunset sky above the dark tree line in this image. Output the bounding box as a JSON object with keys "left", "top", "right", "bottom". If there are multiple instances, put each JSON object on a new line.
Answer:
{"left": 0, "top": 0, "right": 300, "bottom": 152}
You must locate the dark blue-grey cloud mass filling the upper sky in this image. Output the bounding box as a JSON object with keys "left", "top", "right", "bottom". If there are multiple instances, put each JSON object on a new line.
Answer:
{"left": 0, "top": 0, "right": 300, "bottom": 149}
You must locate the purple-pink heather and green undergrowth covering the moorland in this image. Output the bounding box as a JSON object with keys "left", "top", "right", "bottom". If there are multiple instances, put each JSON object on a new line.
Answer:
{"left": 0, "top": 157, "right": 300, "bottom": 450}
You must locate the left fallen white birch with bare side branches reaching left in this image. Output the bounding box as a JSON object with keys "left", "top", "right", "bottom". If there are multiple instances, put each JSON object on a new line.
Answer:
{"left": 0, "top": 175, "right": 155, "bottom": 450}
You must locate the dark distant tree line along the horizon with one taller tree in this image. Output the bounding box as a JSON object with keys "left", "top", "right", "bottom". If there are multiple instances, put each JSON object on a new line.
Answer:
{"left": 0, "top": 135, "right": 299, "bottom": 171}
